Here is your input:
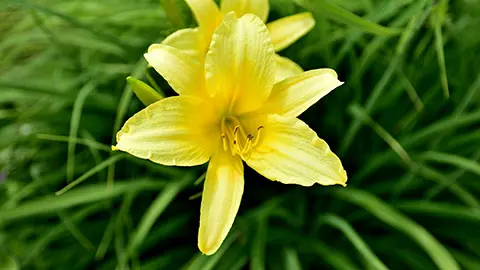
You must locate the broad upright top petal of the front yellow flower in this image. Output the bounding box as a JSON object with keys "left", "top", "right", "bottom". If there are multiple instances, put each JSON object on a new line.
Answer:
{"left": 205, "top": 12, "right": 275, "bottom": 114}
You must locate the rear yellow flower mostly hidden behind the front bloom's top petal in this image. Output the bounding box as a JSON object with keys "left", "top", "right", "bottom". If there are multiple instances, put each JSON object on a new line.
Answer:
{"left": 148, "top": 0, "right": 315, "bottom": 82}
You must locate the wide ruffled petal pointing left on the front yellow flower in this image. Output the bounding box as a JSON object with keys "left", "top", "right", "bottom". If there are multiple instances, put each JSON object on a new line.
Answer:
{"left": 115, "top": 96, "right": 220, "bottom": 166}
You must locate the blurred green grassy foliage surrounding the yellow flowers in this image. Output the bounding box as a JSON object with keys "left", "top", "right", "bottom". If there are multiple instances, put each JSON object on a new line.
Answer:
{"left": 0, "top": 0, "right": 480, "bottom": 270}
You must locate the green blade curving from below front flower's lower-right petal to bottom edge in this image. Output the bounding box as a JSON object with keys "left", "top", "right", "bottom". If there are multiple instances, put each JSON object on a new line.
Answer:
{"left": 334, "top": 188, "right": 460, "bottom": 269}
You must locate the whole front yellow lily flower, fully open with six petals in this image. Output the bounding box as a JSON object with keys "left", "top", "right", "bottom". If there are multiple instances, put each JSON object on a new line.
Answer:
{"left": 114, "top": 13, "right": 347, "bottom": 254}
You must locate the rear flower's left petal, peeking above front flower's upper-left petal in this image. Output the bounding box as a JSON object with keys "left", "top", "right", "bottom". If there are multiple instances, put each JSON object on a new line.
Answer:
{"left": 152, "top": 28, "right": 204, "bottom": 58}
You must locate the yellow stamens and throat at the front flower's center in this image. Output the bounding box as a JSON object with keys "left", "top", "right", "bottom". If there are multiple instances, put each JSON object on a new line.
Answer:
{"left": 221, "top": 116, "right": 263, "bottom": 158}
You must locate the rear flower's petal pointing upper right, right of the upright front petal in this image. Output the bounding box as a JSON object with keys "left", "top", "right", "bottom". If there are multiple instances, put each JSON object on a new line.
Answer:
{"left": 267, "top": 12, "right": 315, "bottom": 51}
